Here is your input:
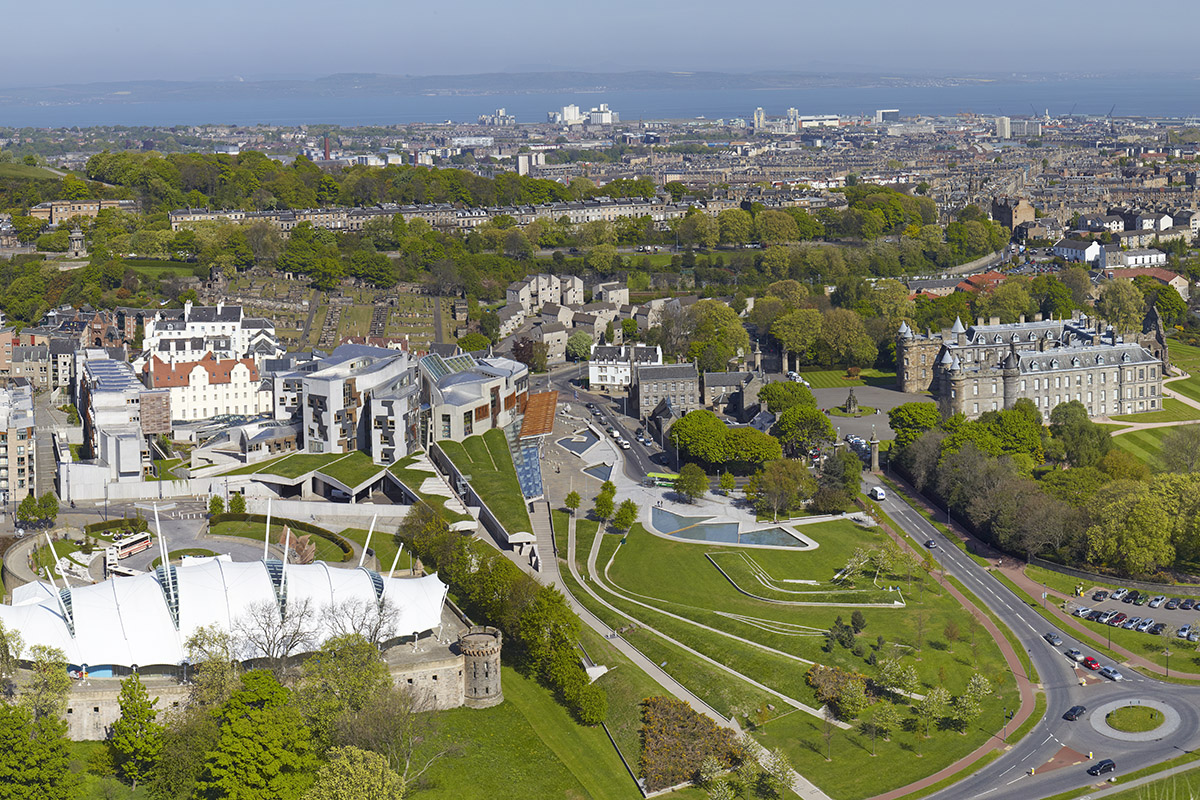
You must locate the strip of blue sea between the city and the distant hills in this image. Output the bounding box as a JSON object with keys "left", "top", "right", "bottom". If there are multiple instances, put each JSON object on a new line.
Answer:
{"left": 0, "top": 77, "right": 1200, "bottom": 127}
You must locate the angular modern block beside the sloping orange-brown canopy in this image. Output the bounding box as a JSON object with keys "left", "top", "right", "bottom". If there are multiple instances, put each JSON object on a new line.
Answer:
{"left": 419, "top": 353, "right": 529, "bottom": 446}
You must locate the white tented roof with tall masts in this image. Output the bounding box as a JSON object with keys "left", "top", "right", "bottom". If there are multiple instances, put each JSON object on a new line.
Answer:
{"left": 0, "top": 557, "right": 446, "bottom": 668}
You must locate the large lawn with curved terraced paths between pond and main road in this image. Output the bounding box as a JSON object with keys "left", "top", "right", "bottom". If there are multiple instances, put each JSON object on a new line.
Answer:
{"left": 559, "top": 506, "right": 1015, "bottom": 800}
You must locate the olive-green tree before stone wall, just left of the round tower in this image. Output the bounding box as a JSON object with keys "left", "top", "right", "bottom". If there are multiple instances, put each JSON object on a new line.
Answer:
{"left": 296, "top": 633, "right": 390, "bottom": 744}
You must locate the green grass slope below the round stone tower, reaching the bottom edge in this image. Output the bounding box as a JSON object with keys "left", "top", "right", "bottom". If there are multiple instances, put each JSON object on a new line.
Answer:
{"left": 419, "top": 667, "right": 657, "bottom": 800}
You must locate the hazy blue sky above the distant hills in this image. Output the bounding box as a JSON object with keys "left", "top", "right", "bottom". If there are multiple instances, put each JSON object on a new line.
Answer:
{"left": 0, "top": 0, "right": 1200, "bottom": 86}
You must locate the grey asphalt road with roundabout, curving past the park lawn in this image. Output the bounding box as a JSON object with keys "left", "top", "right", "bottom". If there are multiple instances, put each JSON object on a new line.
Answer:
{"left": 865, "top": 477, "right": 1200, "bottom": 800}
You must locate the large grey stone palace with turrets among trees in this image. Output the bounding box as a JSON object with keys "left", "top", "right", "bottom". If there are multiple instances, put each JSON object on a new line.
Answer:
{"left": 896, "top": 309, "right": 1166, "bottom": 419}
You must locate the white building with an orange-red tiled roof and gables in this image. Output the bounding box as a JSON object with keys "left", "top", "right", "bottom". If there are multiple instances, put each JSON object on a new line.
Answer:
{"left": 143, "top": 353, "right": 271, "bottom": 421}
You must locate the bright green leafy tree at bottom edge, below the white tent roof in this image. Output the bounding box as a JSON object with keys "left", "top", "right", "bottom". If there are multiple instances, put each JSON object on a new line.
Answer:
{"left": 196, "top": 670, "right": 319, "bottom": 800}
